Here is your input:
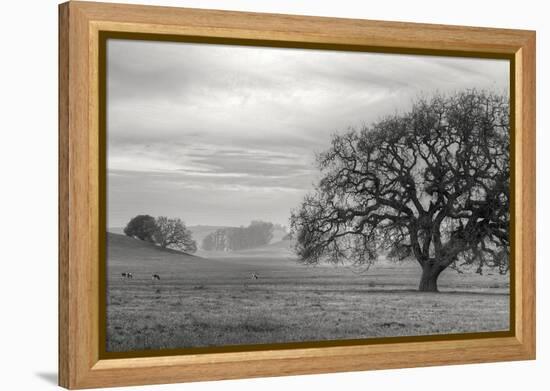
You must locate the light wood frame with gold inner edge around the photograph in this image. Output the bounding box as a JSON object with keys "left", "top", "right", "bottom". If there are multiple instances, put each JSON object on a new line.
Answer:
{"left": 59, "top": 1, "right": 535, "bottom": 389}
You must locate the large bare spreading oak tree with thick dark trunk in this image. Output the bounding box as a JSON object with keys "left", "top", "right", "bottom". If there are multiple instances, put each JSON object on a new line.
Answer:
{"left": 291, "top": 90, "right": 510, "bottom": 291}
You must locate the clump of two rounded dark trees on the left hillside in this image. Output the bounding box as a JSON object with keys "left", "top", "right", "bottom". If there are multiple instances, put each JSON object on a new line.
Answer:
{"left": 124, "top": 215, "right": 197, "bottom": 253}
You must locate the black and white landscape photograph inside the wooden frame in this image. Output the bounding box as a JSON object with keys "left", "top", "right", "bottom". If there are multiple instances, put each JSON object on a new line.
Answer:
{"left": 104, "top": 38, "right": 513, "bottom": 353}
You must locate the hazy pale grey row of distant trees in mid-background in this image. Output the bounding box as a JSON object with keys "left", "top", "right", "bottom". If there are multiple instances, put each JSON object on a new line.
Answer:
{"left": 202, "top": 221, "right": 274, "bottom": 251}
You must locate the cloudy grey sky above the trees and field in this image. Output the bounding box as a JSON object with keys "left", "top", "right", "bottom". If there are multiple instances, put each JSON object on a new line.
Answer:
{"left": 107, "top": 40, "right": 509, "bottom": 227}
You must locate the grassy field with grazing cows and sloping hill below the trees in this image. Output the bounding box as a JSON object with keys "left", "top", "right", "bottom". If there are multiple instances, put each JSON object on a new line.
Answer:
{"left": 107, "top": 234, "right": 509, "bottom": 352}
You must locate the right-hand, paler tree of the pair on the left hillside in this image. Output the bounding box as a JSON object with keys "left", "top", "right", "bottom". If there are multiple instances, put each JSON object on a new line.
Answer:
{"left": 153, "top": 216, "right": 197, "bottom": 253}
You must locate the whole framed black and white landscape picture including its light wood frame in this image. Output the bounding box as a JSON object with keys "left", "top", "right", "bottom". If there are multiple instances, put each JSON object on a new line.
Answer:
{"left": 59, "top": 2, "right": 535, "bottom": 388}
